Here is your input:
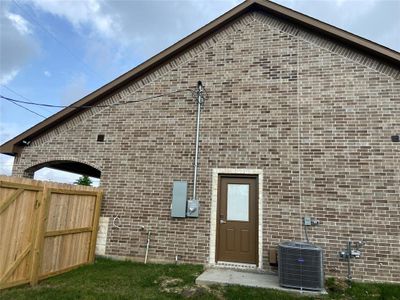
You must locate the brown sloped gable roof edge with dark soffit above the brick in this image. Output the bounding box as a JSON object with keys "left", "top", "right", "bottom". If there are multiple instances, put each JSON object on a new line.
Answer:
{"left": 0, "top": 0, "right": 400, "bottom": 155}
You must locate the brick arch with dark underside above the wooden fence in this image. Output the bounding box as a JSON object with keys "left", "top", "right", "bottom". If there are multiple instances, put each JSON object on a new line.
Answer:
{"left": 23, "top": 157, "right": 101, "bottom": 178}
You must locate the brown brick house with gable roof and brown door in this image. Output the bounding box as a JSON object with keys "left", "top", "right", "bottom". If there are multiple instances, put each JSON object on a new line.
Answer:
{"left": 0, "top": 0, "right": 400, "bottom": 282}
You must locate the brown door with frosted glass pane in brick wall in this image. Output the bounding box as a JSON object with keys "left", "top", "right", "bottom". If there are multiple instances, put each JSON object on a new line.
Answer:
{"left": 217, "top": 175, "right": 258, "bottom": 264}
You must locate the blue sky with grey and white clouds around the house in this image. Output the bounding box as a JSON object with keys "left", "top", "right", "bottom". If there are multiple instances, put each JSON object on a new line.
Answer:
{"left": 0, "top": 0, "right": 400, "bottom": 182}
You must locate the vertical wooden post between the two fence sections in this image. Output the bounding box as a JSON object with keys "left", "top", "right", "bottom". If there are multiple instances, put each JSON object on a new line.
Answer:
{"left": 30, "top": 185, "right": 51, "bottom": 286}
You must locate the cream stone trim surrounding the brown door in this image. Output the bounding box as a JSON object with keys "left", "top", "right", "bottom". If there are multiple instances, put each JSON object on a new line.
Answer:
{"left": 209, "top": 169, "right": 263, "bottom": 269}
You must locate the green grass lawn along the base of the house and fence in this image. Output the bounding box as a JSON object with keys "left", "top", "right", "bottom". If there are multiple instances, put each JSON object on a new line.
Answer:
{"left": 0, "top": 259, "right": 400, "bottom": 300}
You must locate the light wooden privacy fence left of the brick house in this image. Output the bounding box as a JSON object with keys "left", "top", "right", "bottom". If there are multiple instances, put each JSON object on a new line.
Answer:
{"left": 0, "top": 176, "right": 103, "bottom": 289}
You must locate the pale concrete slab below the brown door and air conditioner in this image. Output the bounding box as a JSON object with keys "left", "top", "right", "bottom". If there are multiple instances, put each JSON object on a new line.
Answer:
{"left": 196, "top": 268, "right": 326, "bottom": 295}
